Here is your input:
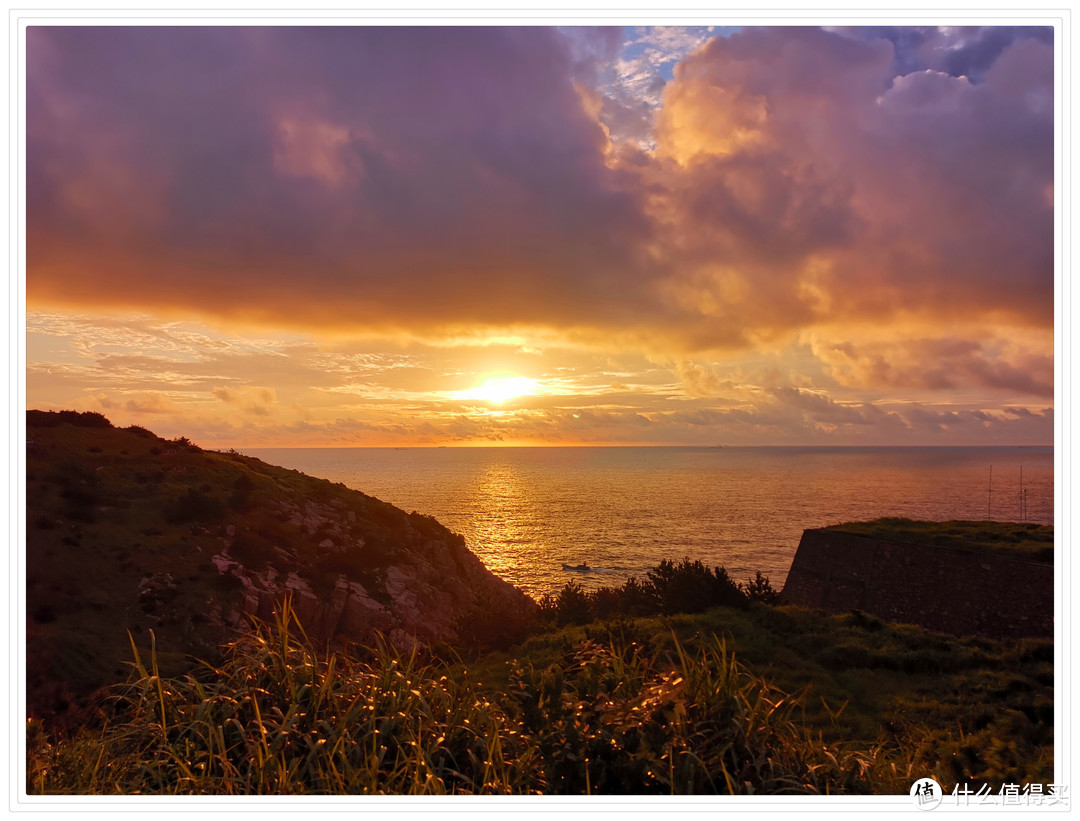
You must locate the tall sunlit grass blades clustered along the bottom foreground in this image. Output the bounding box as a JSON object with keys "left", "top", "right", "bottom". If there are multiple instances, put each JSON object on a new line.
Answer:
{"left": 27, "top": 613, "right": 902, "bottom": 794}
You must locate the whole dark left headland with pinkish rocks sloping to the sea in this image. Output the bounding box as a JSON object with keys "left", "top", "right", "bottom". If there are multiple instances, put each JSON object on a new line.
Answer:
{"left": 25, "top": 412, "right": 536, "bottom": 714}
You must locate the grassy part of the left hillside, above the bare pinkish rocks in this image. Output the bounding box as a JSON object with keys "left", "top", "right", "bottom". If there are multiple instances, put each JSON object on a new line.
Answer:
{"left": 26, "top": 412, "right": 529, "bottom": 716}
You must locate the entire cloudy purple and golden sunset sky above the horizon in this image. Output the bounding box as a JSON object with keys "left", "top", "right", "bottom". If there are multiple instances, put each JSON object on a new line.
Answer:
{"left": 25, "top": 26, "right": 1054, "bottom": 448}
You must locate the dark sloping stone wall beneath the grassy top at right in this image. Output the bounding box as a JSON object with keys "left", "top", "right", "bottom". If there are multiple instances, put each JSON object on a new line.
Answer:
{"left": 782, "top": 530, "right": 1054, "bottom": 638}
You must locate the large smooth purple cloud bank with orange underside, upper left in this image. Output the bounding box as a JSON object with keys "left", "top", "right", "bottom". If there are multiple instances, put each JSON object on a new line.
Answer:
{"left": 27, "top": 27, "right": 649, "bottom": 329}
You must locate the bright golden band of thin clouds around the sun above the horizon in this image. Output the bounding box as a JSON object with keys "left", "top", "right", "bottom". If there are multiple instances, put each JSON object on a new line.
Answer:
{"left": 27, "top": 306, "right": 1053, "bottom": 447}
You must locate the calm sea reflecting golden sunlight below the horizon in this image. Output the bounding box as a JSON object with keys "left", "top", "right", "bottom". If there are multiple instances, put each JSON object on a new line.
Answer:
{"left": 238, "top": 447, "right": 1054, "bottom": 596}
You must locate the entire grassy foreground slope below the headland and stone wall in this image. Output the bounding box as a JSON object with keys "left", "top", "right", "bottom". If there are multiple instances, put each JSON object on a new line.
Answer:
{"left": 27, "top": 604, "right": 1053, "bottom": 795}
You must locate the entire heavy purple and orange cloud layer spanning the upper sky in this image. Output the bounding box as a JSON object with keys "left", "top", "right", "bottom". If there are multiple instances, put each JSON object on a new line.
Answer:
{"left": 27, "top": 26, "right": 1053, "bottom": 415}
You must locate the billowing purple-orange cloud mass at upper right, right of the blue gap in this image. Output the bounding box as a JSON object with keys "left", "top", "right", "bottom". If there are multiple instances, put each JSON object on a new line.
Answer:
{"left": 643, "top": 28, "right": 1053, "bottom": 348}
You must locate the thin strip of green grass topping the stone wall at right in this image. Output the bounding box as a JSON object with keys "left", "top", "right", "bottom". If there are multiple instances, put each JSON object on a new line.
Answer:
{"left": 824, "top": 519, "right": 1054, "bottom": 564}
